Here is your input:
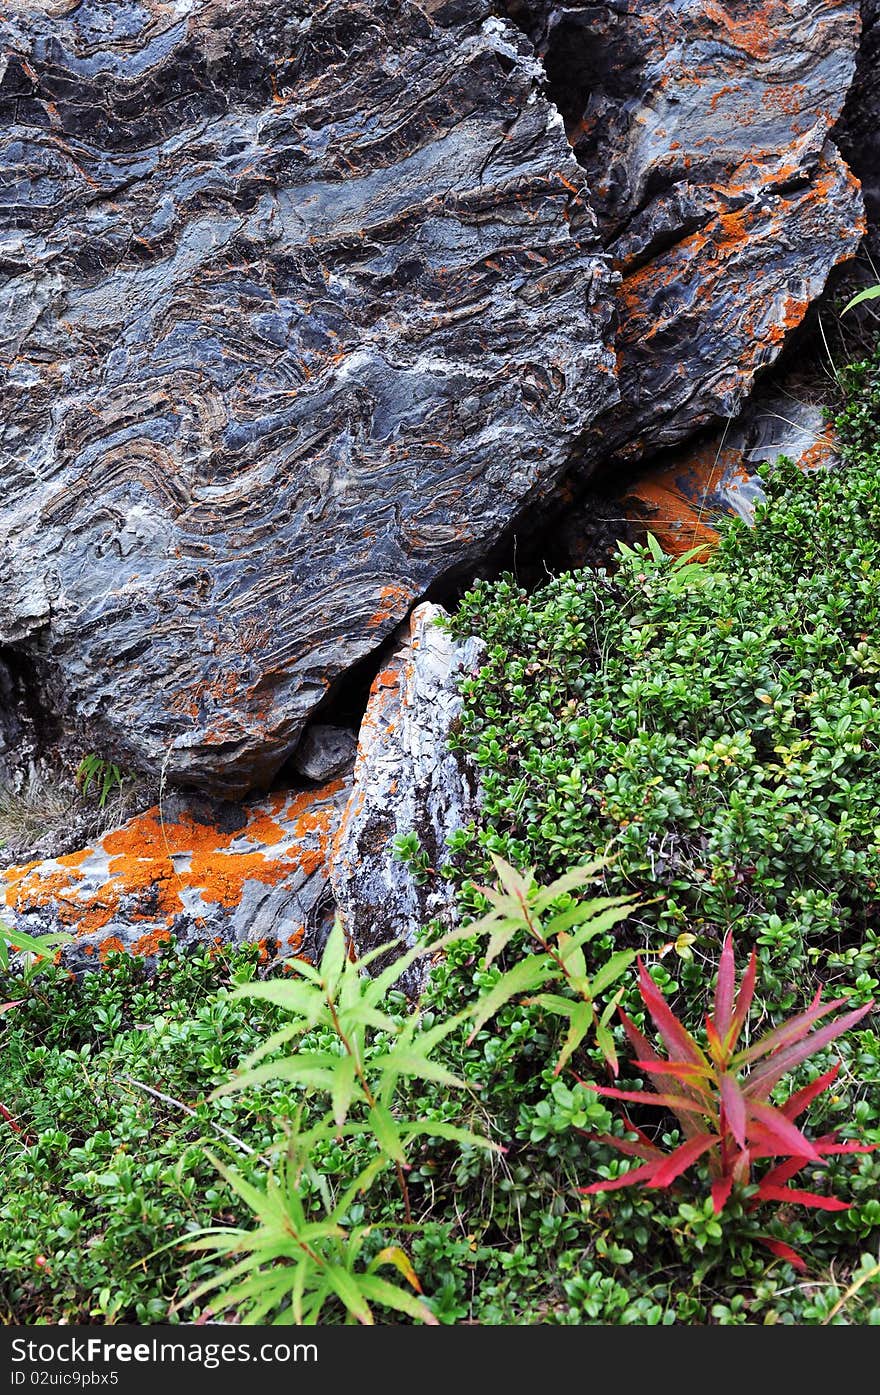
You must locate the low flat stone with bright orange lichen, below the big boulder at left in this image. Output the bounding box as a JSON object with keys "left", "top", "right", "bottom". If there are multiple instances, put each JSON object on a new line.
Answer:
{"left": 0, "top": 781, "right": 349, "bottom": 972}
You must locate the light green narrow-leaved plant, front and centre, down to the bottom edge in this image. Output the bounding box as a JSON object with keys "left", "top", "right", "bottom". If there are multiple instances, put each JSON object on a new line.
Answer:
{"left": 178, "top": 921, "right": 498, "bottom": 1324}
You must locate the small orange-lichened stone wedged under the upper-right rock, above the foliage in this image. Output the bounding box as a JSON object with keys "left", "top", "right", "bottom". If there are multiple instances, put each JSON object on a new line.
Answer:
{"left": 621, "top": 392, "right": 838, "bottom": 557}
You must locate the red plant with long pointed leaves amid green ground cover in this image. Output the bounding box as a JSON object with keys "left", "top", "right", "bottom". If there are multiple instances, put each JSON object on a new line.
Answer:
{"left": 580, "top": 935, "right": 876, "bottom": 1268}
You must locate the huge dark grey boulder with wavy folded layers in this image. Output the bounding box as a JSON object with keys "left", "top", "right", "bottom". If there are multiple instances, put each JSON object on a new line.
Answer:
{"left": 0, "top": 0, "right": 616, "bottom": 797}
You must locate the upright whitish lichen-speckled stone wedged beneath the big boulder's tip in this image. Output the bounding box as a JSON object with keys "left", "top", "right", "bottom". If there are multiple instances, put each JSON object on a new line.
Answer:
{"left": 331, "top": 605, "right": 485, "bottom": 954}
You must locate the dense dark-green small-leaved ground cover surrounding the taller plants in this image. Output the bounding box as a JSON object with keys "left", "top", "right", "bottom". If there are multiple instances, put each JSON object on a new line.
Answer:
{"left": 0, "top": 351, "right": 880, "bottom": 1324}
